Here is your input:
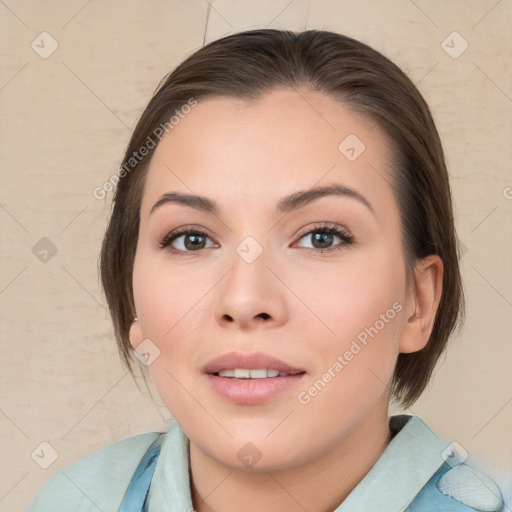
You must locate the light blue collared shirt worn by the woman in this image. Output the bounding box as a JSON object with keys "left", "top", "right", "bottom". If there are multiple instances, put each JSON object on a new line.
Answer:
{"left": 28, "top": 415, "right": 504, "bottom": 512}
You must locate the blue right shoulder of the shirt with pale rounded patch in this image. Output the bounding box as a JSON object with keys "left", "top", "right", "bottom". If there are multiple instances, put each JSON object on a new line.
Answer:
{"left": 407, "top": 463, "right": 505, "bottom": 512}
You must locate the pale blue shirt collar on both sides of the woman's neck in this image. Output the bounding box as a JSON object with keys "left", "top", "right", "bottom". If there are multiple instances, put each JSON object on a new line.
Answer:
{"left": 148, "top": 414, "right": 450, "bottom": 512}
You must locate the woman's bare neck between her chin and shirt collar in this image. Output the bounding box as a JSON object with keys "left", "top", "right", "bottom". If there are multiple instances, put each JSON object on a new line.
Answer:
{"left": 190, "top": 404, "right": 391, "bottom": 512}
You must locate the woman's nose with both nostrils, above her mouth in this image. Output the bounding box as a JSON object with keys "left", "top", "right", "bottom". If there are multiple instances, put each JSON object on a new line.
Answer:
{"left": 213, "top": 245, "right": 288, "bottom": 330}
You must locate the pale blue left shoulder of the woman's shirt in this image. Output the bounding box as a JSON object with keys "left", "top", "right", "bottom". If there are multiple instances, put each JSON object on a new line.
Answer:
{"left": 28, "top": 432, "right": 160, "bottom": 512}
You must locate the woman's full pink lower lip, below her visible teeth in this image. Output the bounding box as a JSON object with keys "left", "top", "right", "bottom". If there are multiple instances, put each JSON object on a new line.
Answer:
{"left": 206, "top": 373, "right": 305, "bottom": 405}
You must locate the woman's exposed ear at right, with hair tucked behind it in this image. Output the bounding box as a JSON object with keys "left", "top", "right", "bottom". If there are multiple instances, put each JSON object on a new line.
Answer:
{"left": 400, "top": 255, "right": 444, "bottom": 353}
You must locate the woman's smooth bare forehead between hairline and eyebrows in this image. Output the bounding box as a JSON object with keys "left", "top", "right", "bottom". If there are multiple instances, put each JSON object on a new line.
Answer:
{"left": 142, "top": 89, "right": 393, "bottom": 220}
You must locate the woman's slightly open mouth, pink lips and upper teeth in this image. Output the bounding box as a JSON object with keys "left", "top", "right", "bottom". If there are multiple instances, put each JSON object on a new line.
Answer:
{"left": 203, "top": 352, "right": 306, "bottom": 405}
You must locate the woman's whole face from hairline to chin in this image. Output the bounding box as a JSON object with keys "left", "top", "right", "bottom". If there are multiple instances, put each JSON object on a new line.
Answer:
{"left": 131, "top": 89, "right": 408, "bottom": 470}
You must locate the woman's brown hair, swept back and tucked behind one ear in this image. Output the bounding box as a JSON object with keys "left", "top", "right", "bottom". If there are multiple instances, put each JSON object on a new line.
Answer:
{"left": 100, "top": 29, "right": 464, "bottom": 407}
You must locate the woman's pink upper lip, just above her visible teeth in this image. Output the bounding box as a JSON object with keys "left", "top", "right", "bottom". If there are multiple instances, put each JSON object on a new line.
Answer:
{"left": 203, "top": 352, "right": 304, "bottom": 375}
